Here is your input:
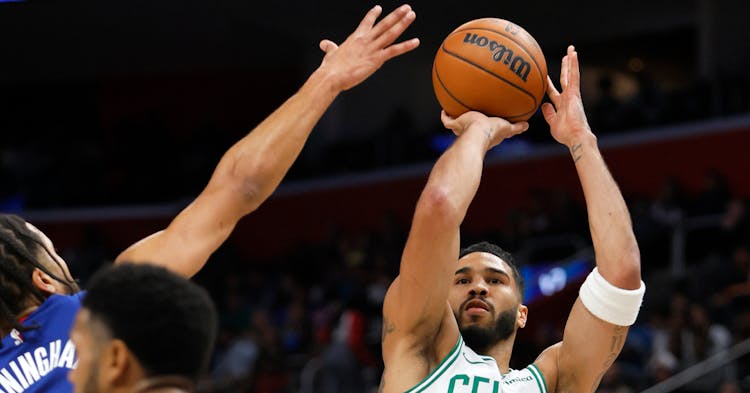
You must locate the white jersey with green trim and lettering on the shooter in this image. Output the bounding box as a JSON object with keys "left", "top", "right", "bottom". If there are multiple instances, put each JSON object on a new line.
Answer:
{"left": 406, "top": 336, "right": 547, "bottom": 393}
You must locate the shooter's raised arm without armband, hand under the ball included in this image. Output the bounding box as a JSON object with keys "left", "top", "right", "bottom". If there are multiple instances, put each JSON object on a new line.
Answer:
{"left": 382, "top": 112, "right": 528, "bottom": 391}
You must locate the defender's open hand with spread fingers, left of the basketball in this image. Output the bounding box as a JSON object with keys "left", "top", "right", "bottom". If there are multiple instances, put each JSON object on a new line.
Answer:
{"left": 320, "top": 4, "right": 419, "bottom": 91}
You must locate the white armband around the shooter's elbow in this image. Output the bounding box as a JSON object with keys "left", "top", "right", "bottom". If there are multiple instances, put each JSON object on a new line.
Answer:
{"left": 578, "top": 268, "right": 646, "bottom": 326}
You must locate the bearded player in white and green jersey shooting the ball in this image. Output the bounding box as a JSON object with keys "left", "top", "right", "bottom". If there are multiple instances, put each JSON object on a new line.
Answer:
{"left": 380, "top": 46, "right": 644, "bottom": 393}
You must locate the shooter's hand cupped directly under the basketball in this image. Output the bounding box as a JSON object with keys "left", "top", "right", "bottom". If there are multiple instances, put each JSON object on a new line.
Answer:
{"left": 440, "top": 111, "right": 529, "bottom": 150}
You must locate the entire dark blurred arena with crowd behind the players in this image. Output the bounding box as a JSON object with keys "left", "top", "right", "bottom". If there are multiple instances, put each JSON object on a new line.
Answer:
{"left": 0, "top": 0, "right": 750, "bottom": 392}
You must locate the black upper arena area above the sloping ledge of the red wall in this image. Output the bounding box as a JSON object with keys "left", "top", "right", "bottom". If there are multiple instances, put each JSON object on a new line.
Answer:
{"left": 0, "top": 0, "right": 750, "bottom": 208}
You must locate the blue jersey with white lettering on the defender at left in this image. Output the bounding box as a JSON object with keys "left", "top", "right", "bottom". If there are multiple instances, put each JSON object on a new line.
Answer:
{"left": 0, "top": 292, "right": 83, "bottom": 393}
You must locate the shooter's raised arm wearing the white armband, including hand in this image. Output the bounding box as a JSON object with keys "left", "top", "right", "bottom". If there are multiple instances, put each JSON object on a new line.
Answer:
{"left": 537, "top": 46, "right": 644, "bottom": 392}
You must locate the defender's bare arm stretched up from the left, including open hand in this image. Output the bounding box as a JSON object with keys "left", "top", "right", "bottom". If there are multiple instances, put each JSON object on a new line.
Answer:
{"left": 116, "top": 5, "right": 419, "bottom": 277}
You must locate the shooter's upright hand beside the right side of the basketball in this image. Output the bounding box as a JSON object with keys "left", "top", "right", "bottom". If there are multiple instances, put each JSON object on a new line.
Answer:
{"left": 542, "top": 45, "right": 593, "bottom": 148}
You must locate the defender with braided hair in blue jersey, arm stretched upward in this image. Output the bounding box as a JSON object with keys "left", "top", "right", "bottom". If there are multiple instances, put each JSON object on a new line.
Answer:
{"left": 0, "top": 5, "right": 419, "bottom": 392}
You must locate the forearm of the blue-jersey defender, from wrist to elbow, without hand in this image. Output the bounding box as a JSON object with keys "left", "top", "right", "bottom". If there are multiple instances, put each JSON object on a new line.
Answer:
{"left": 209, "top": 70, "right": 339, "bottom": 213}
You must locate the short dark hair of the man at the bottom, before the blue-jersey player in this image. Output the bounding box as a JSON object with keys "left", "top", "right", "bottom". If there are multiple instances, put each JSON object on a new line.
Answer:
{"left": 83, "top": 263, "right": 217, "bottom": 382}
